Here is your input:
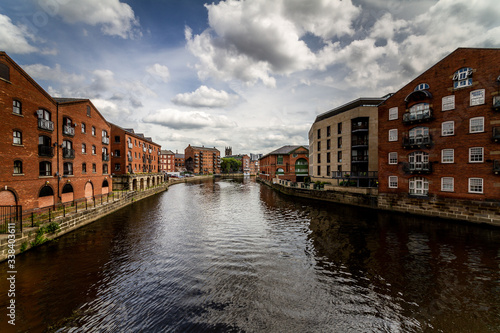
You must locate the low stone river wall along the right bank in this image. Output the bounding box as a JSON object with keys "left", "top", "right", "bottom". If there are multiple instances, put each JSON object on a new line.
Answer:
{"left": 257, "top": 178, "right": 500, "bottom": 227}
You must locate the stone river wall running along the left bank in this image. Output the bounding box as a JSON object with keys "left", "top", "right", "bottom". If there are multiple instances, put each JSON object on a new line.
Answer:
{"left": 0, "top": 176, "right": 211, "bottom": 262}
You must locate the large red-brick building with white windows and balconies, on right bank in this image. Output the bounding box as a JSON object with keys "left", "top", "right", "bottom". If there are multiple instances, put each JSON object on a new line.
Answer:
{"left": 378, "top": 48, "right": 500, "bottom": 201}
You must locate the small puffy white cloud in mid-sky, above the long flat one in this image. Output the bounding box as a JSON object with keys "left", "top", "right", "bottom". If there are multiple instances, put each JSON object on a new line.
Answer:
{"left": 172, "top": 86, "right": 238, "bottom": 108}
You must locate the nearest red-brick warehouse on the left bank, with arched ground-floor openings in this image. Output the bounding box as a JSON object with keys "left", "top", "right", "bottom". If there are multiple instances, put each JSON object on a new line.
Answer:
{"left": 0, "top": 52, "right": 112, "bottom": 209}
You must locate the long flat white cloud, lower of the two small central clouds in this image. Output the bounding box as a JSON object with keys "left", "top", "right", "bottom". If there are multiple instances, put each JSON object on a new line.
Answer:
{"left": 143, "top": 109, "right": 237, "bottom": 129}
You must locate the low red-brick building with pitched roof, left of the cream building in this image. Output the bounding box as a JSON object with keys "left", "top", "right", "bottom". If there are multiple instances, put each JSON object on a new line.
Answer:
{"left": 259, "top": 145, "right": 309, "bottom": 182}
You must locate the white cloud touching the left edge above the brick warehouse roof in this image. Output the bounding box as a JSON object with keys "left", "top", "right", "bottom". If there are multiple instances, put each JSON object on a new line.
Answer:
{"left": 0, "top": 14, "right": 38, "bottom": 53}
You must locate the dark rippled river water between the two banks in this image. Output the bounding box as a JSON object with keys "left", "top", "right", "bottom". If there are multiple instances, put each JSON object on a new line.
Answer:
{"left": 0, "top": 180, "right": 500, "bottom": 332}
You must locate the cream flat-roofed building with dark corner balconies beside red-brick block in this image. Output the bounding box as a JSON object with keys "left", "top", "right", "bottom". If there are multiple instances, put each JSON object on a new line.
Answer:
{"left": 309, "top": 97, "right": 386, "bottom": 187}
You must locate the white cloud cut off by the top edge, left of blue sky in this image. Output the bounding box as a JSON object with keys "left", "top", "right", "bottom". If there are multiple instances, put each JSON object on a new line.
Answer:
{"left": 38, "top": 0, "right": 140, "bottom": 38}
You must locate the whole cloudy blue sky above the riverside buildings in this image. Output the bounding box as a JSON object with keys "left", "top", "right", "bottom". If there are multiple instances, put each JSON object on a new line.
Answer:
{"left": 0, "top": 0, "right": 500, "bottom": 153}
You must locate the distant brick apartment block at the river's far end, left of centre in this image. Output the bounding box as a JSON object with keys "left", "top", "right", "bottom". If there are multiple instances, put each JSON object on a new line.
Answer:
{"left": 184, "top": 145, "right": 221, "bottom": 174}
